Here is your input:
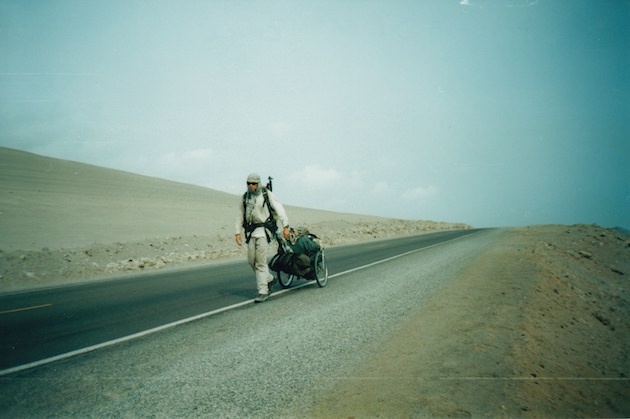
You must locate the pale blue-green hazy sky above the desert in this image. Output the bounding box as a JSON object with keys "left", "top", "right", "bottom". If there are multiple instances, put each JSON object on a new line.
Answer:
{"left": 0, "top": 0, "right": 630, "bottom": 228}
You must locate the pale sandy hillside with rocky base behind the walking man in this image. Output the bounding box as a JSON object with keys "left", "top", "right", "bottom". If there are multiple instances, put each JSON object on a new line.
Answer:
{"left": 0, "top": 148, "right": 469, "bottom": 292}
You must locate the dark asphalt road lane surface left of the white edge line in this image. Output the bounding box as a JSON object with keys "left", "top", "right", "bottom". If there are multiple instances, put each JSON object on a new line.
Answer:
{"left": 0, "top": 230, "right": 475, "bottom": 370}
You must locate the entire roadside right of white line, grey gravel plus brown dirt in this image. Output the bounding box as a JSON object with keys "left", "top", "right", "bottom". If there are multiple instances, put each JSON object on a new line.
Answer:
{"left": 0, "top": 226, "right": 630, "bottom": 418}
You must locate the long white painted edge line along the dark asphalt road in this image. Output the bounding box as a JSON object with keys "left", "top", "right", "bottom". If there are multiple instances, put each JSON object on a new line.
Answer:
{"left": 0, "top": 232, "right": 477, "bottom": 377}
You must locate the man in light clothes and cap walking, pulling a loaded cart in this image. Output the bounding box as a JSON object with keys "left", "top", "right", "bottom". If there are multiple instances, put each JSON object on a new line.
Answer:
{"left": 236, "top": 173, "right": 289, "bottom": 303}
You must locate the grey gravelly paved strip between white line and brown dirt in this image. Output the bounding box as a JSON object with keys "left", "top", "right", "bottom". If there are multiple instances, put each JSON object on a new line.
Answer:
{"left": 0, "top": 230, "right": 500, "bottom": 418}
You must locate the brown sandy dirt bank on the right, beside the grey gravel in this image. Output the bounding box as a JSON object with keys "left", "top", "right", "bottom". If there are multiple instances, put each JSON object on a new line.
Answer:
{"left": 309, "top": 229, "right": 630, "bottom": 417}
